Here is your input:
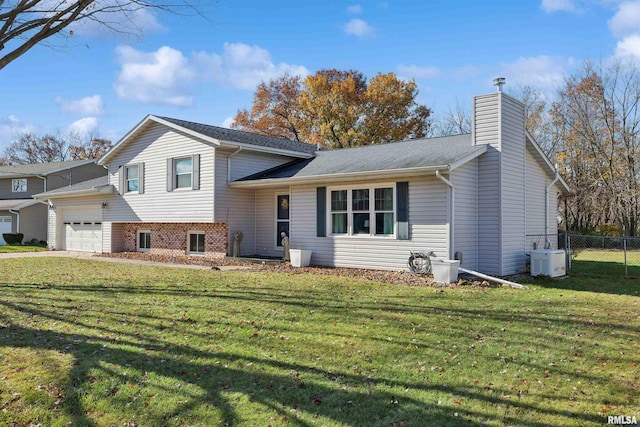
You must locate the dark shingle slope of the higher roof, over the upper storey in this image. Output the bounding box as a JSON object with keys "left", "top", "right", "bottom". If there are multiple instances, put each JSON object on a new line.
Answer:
{"left": 158, "top": 116, "right": 317, "bottom": 154}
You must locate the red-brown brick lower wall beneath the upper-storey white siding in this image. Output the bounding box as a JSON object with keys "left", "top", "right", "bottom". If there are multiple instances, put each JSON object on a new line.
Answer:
{"left": 123, "top": 222, "right": 229, "bottom": 258}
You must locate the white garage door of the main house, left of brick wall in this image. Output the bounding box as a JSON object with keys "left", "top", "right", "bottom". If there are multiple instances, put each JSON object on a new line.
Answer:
{"left": 62, "top": 206, "right": 102, "bottom": 252}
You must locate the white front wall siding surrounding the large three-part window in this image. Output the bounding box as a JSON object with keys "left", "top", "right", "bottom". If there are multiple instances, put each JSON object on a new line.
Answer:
{"left": 272, "top": 176, "right": 449, "bottom": 270}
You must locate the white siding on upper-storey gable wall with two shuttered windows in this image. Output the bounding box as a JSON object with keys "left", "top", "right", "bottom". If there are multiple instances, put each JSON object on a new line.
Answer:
{"left": 105, "top": 123, "right": 214, "bottom": 222}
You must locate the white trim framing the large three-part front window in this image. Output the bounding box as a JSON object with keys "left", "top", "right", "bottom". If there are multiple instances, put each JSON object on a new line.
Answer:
{"left": 326, "top": 182, "right": 398, "bottom": 239}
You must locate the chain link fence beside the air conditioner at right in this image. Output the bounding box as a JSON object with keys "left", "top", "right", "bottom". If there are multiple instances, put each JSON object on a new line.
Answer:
{"left": 527, "top": 233, "right": 640, "bottom": 277}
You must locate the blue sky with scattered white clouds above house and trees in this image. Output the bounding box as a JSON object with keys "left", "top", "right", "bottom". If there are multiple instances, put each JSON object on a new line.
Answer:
{"left": 0, "top": 0, "right": 640, "bottom": 151}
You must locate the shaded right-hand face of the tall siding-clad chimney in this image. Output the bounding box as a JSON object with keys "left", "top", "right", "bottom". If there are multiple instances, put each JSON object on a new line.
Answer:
{"left": 500, "top": 96, "right": 526, "bottom": 274}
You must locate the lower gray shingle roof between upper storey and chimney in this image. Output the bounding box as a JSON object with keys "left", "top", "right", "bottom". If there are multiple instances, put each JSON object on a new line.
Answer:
{"left": 239, "top": 135, "right": 487, "bottom": 181}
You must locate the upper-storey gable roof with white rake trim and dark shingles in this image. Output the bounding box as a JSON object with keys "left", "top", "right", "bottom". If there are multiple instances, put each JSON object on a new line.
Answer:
{"left": 98, "top": 114, "right": 317, "bottom": 165}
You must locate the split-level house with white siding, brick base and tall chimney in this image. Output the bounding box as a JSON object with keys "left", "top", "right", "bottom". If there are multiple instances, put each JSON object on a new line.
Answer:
{"left": 37, "top": 92, "right": 568, "bottom": 275}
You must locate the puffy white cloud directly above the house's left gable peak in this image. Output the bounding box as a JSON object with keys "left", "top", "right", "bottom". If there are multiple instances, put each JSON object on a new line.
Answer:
{"left": 114, "top": 46, "right": 196, "bottom": 106}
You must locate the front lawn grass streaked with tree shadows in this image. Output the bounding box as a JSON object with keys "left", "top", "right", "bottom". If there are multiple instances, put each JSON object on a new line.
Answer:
{"left": 0, "top": 258, "right": 640, "bottom": 427}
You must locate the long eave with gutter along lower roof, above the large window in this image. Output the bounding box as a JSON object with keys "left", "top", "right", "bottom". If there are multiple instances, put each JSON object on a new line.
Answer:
{"left": 227, "top": 165, "right": 451, "bottom": 188}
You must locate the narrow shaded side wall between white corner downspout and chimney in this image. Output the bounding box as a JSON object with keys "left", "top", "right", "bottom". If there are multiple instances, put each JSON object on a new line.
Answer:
{"left": 450, "top": 159, "right": 478, "bottom": 270}
